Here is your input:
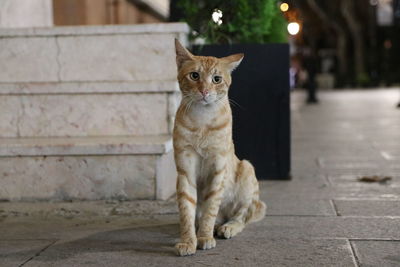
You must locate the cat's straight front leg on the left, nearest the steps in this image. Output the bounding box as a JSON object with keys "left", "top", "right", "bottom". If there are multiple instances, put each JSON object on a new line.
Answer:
{"left": 175, "top": 148, "right": 200, "bottom": 256}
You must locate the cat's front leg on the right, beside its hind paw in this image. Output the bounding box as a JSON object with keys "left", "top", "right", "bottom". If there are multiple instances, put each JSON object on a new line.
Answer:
{"left": 197, "top": 157, "right": 226, "bottom": 249}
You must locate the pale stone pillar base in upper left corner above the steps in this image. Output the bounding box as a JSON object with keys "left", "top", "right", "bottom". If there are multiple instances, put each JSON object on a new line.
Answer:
{"left": 0, "top": 0, "right": 53, "bottom": 28}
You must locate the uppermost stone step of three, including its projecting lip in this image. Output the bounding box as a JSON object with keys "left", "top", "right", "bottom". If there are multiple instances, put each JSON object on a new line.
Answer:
{"left": 0, "top": 23, "right": 189, "bottom": 83}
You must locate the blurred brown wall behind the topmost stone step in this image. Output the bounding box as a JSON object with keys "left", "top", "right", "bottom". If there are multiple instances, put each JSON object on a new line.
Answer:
{"left": 53, "top": 0, "right": 165, "bottom": 25}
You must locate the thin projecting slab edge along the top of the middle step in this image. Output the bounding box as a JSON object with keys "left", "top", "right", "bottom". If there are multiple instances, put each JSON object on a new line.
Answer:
{"left": 0, "top": 80, "right": 179, "bottom": 95}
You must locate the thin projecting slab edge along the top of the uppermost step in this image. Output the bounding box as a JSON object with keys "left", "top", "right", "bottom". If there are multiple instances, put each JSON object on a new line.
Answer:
{"left": 0, "top": 23, "right": 189, "bottom": 38}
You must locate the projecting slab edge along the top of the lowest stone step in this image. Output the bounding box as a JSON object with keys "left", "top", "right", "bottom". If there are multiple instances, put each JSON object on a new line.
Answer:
{"left": 0, "top": 135, "right": 172, "bottom": 157}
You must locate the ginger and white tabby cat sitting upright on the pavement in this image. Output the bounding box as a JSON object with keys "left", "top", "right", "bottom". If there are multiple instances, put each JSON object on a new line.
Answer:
{"left": 173, "top": 40, "right": 266, "bottom": 256}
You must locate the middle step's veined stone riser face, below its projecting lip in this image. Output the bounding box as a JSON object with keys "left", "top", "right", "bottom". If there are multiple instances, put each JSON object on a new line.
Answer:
{"left": 0, "top": 94, "right": 168, "bottom": 137}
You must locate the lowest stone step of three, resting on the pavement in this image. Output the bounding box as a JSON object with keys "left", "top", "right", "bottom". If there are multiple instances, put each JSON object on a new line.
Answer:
{"left": 0, "top": 135, "right": 176, "bottom": 201}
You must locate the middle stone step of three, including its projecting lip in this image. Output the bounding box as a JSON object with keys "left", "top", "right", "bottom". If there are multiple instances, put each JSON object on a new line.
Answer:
{"left": 0, "top": 85, "right": 180, "bottom": 138}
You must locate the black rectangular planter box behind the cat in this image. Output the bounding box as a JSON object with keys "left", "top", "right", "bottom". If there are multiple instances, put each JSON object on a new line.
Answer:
{"left": 192, "top": 44, "right": 290, "bottom": 179}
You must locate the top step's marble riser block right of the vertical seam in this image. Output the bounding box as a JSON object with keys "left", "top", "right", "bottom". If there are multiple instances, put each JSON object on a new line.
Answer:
{"left": 58, "top": 34, "right": 177, "bottom": 81}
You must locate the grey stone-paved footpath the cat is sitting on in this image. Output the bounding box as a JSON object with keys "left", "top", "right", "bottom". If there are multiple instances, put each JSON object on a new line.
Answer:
{"left": 0, "top": 90, "right": 400, "bottom": 267}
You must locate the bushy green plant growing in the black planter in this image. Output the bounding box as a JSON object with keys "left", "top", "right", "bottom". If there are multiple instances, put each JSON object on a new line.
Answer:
{"left": 178, "top": 0, "right": 287, "bottom": 44}
